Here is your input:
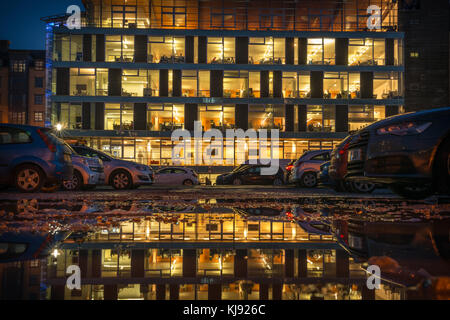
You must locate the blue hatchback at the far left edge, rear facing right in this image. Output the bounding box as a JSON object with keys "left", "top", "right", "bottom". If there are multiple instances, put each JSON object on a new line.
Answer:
{"left": 0, "top": 124, "right": 73, "bottom": 192}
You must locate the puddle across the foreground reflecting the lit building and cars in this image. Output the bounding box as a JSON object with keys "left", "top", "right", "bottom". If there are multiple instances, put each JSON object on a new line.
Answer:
{"left": 0, "top": 198, "right": 450, "bottom": 300}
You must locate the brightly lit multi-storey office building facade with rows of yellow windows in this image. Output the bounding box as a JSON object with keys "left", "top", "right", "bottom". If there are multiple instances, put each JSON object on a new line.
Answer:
{"left": 44, "top": 0, "right": 404, "bottom": 174}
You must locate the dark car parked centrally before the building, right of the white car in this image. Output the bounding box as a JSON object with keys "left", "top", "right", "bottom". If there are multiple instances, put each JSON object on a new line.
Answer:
{"left": 216, "top": 164, "right": 284, "bottom": 186}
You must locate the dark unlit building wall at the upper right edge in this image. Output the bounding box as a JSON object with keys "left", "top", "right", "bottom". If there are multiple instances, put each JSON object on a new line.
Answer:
{"left": 399, "top": 0, "right": 450, "bottom": 112}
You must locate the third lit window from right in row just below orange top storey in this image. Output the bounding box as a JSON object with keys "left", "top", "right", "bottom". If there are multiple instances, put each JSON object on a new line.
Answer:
{"left": 248, "top": 37, "right": 286, "bottom": 64}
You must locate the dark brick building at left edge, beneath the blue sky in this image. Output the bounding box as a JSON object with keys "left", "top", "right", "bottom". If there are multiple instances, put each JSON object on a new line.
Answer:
{"left": 0, "top": 40, "right": 46, "bottom": 126}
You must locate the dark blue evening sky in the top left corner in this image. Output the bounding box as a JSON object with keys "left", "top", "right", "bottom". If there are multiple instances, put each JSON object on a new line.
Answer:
{"left": 0, "top": 0, "right": 84, "bottom": 50}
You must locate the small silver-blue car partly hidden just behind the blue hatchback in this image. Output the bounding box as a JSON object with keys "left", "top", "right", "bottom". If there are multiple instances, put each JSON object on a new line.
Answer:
{"left": 62, "top": 153, "right": 105, "bottom": 191}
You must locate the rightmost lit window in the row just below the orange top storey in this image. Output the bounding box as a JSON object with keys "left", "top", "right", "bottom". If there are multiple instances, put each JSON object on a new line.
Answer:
{"left": 348, "top": 39, "right": 386, "bottom": 66}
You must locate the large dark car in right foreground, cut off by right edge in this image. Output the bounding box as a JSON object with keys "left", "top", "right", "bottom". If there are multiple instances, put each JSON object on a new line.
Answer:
{"left": 346, "top": 108, "right": 450, "bottom": 199}
